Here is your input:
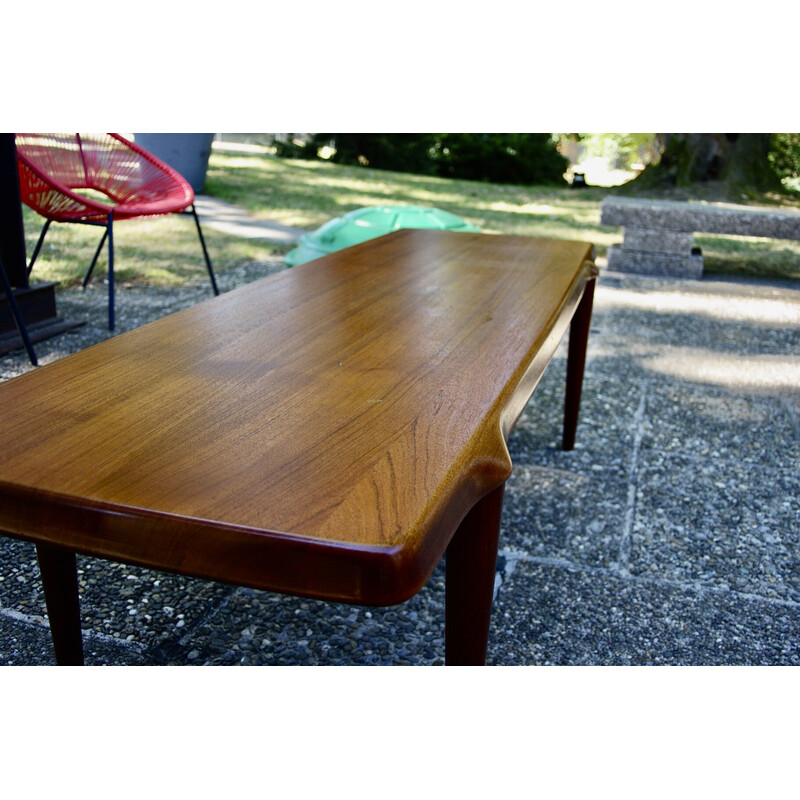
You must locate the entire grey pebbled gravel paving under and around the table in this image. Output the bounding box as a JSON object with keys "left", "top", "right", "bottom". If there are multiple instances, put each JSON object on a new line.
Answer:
{"left": 0, "top": 259, "right": 800, "bottom": 665}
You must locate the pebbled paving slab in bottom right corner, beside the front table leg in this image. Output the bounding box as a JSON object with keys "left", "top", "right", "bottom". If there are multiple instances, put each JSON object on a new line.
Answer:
{"left": 488, "top": 559, "right": 800, "bottom": 666}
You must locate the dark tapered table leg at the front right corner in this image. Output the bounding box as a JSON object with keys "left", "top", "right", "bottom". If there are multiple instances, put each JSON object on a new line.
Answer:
{"left": 445, "top": 484, "right": 505, "bottom": 666}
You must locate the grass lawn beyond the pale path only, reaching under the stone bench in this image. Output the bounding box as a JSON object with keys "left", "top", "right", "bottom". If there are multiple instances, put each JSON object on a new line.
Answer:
{"left": 207, "top": 148, "right": 800, "bottom": 280}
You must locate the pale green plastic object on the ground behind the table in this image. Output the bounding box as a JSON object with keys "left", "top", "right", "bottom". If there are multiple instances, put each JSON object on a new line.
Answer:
{"left": 284, "top": 206, "right": 480, "bottom": 267}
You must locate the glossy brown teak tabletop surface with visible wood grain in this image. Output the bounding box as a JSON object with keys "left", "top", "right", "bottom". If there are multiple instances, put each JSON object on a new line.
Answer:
{"left": 0, "top": 230, "right": 591, "bottom": 600}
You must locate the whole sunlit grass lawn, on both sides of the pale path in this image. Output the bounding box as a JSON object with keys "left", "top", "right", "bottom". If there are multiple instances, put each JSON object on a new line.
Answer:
{"left": 23, "top": 145, "right": 800, "bottom": 286}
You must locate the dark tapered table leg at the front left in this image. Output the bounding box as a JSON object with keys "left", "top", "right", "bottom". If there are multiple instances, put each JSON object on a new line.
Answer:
{"left": 36, "top": 544, "right": 83, "bottom": 667}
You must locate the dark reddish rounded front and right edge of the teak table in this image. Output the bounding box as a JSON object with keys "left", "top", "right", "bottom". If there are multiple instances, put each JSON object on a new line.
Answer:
{"left": 0, "top": 243, "right": 598, "bottom": 605}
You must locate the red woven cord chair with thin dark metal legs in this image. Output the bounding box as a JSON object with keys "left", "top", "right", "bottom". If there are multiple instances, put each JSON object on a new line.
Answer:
{"left": 16, "top": 133, "right": 219, "bottom": 330}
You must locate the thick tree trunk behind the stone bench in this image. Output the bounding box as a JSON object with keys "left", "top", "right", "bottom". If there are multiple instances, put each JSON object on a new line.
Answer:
{"left": 628, "top": 133, "right": 782, "bottom": 197}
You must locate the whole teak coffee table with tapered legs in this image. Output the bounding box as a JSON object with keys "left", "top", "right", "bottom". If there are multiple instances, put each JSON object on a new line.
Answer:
{"left": 0, "top": 230, "right": 597, "bottom": 665}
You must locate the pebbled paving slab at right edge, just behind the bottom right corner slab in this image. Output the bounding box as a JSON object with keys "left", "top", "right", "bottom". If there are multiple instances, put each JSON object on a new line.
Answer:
{"left": 628, "top": 451, "right": 800, "bottom": 601}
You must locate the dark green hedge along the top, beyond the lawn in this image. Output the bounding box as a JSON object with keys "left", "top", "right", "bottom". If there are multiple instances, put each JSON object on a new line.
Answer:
{"left": 278, "top": 133, "right": 568, "bottom": 186}
